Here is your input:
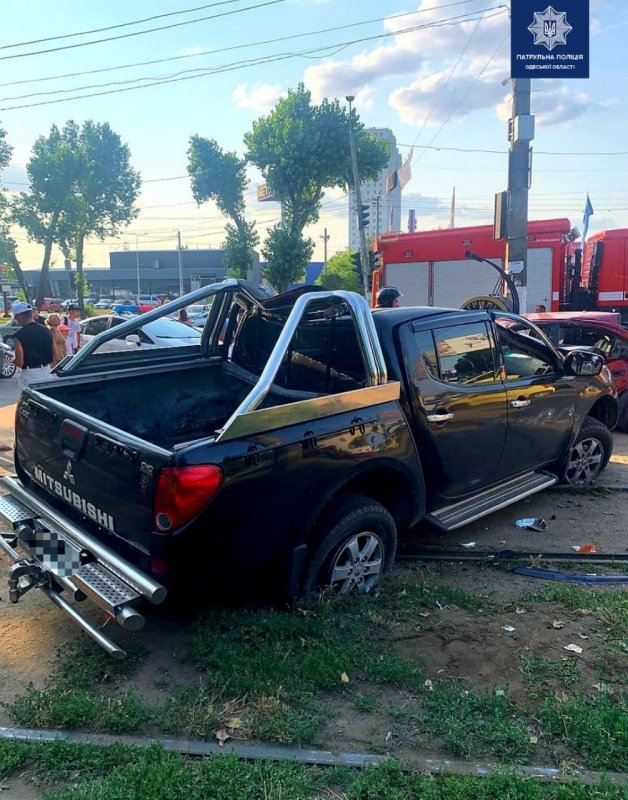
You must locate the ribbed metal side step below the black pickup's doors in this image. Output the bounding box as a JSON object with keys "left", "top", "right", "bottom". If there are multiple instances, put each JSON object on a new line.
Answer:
{"left": 426, "top": 472, "right": 558, "bottom": 531}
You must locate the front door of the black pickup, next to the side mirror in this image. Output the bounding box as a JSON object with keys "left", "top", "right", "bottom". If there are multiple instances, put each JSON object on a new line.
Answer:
{"left": 496, "top": 325, "right": 577, "bottom": 475}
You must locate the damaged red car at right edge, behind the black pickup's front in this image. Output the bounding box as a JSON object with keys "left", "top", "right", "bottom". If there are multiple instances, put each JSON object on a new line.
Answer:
{"left": 525, "top": 311, "right": 628, "bottom": 433}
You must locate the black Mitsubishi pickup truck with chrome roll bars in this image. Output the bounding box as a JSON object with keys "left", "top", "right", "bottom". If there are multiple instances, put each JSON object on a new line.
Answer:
{"left": 0, "top": 280, "right": 617, "bottom": 656}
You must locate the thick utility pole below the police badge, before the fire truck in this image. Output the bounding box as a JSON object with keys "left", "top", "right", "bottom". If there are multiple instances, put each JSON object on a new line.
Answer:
{"left": 506, "top": 78, "right": 534, "bottom": 314}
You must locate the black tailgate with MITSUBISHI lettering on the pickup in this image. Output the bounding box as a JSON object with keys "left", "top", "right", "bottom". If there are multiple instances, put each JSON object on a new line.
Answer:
{"left": 15, "top": 387, "right": 171, "bottom": 551}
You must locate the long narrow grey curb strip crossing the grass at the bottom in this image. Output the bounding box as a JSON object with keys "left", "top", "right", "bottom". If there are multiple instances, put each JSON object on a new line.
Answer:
{"left": 0, "top": 727, "right": 628, "bottom": 785}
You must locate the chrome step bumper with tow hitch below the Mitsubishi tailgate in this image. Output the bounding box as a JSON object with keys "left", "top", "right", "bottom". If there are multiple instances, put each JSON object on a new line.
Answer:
{"left": 0, "top": 477, "right": 166, "bottom": 658}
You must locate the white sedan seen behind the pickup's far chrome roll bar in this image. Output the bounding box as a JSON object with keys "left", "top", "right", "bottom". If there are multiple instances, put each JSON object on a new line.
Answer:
{"left": 81, "top": 314, "right": 201, "bottom": 353}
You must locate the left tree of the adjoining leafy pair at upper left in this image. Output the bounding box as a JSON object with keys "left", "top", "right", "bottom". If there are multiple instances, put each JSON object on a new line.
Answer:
{"left": 12, "top": 121, "right": 81, "bottom": 305}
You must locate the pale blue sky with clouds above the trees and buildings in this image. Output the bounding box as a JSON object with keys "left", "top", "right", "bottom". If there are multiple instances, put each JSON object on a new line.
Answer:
{"left": 0, "top": 0, "right": 628, "bottom": 267}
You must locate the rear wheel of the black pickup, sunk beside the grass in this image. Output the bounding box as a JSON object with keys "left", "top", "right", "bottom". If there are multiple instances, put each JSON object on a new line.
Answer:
{"left": 302, "top": 495, "right": 397, "bottom": 597}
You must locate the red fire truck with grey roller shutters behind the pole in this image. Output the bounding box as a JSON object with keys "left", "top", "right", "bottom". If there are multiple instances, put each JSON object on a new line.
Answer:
{"left": 373, "top": 219, "right": 628, "bottom": 320}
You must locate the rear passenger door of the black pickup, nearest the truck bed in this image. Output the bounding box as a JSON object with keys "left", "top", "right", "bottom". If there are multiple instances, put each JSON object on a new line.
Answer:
{"left": 402, "top": 315, "right": 508, "bottom": 499}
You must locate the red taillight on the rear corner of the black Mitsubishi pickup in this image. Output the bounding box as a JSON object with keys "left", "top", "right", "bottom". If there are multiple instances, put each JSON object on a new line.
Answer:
{"left": 153, "top": 466, "right": 223, "bottom": 533}
